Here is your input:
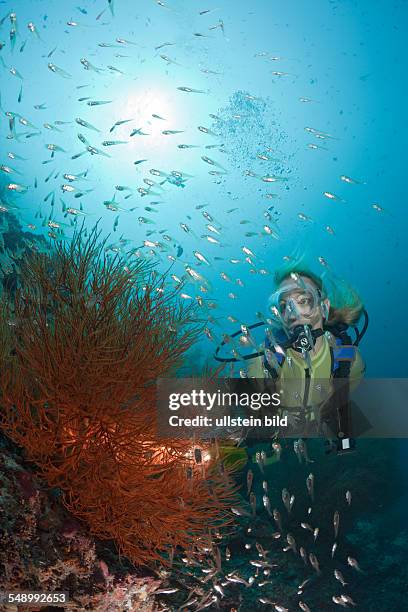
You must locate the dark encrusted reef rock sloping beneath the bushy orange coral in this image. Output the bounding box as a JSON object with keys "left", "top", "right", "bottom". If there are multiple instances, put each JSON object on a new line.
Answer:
{"left": 0, "top": 434, "right": 162, "bottom": 612}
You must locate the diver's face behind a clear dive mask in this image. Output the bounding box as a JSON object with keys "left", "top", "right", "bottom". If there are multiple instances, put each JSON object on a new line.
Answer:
{"left": 279, "top": 276, "right": 323, "bottom": 329}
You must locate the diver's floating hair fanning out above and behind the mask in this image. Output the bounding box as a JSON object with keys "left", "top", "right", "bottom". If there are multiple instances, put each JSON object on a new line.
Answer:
{"left": 274, "top": 265, "right": 364, "bottom": 327}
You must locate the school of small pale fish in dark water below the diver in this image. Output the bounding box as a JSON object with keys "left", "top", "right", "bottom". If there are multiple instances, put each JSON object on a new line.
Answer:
{"left": 153, "top": 439, "right": 366, "bottom": 612}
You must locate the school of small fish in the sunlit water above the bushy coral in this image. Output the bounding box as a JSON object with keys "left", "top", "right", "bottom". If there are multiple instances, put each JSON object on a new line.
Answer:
{"left": 0, "top": 0, "right": 387, "bottom": 357}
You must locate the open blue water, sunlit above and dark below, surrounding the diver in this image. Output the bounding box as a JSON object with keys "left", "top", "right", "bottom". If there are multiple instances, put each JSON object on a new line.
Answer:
{"left": 0, "top": 0, "right": 408, "bottom": 612}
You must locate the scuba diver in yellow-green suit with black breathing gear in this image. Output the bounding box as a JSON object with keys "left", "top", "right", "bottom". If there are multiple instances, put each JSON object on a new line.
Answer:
{"left": 215, "top": 267, "right": 368, "bottom": 463}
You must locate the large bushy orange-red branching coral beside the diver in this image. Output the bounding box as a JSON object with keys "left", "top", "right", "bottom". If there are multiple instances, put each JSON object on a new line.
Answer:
{"left": 0, "top": 228, "right": 236, "bottom": 565}
